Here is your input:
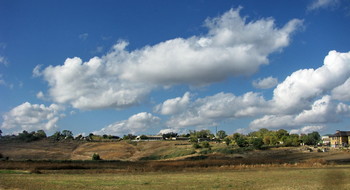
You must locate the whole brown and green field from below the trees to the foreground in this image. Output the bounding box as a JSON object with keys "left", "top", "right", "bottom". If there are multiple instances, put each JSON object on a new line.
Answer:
{"left": 0, "top": 140, "right": 350, "bottom": 190}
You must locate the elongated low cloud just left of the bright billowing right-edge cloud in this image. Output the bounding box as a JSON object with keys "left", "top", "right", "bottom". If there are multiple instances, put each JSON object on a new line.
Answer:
{"left": 163, "top": 92, "right": 267, "bottom": 128}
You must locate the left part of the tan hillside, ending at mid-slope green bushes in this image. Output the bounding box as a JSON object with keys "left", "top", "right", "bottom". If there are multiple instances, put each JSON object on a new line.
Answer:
{"left": 0, "top": 140, "right": 194, "bottom": 161}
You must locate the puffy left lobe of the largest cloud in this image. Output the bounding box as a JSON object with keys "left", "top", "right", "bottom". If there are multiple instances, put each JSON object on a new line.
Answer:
{"left": 36, "top": 57, "right": 149, "bottom": 109}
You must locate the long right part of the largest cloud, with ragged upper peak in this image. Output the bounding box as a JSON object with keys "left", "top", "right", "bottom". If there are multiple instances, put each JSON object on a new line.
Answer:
{"left": 117, "top": 9, "right": 301, "bottom": 85}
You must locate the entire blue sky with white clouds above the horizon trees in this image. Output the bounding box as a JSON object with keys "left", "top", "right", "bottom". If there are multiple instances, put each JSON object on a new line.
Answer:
{"left": 0, "top": 0, "right": 350, "bottom": 135}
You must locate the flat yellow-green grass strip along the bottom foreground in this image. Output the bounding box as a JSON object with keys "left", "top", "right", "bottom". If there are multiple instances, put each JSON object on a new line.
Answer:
{"left": 0, "top": 166, "right": 350, "bottom": 190}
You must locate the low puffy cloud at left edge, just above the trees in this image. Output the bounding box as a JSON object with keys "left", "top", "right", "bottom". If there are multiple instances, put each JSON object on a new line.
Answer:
{"left": 1, "top": 102, "right": 62, "bottom": 132}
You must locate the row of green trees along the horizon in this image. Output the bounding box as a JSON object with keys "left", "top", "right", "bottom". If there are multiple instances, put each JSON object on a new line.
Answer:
{"left": 1, "top": 128, "right": 321, "bottom": 149}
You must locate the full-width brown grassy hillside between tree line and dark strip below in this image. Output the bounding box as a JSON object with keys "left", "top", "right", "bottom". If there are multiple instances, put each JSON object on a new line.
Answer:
{"left": 0, "top": 140, "right": 350, "bottom": 162}
